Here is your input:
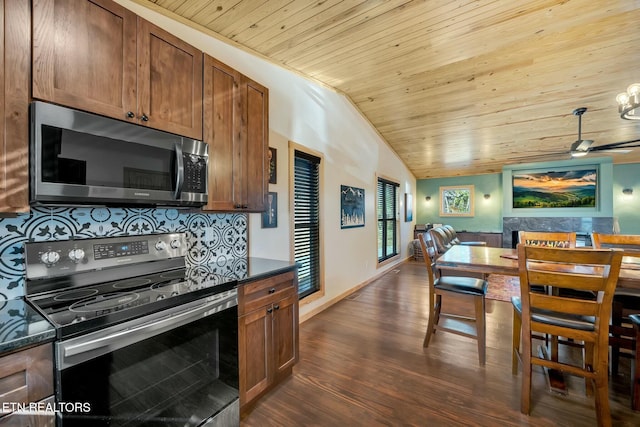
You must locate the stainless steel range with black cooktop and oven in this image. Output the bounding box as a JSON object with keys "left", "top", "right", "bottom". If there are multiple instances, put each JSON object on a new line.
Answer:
{"left": 25, "top": 233, "right": 239, "bottom": 427}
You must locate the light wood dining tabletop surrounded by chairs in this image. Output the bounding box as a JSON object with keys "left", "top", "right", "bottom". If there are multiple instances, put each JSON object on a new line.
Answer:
{"left": 435, "top": 245, "right": 640, "bottom": 291}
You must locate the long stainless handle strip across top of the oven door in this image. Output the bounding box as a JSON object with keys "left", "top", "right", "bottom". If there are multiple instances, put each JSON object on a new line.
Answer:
{"left": 58, "top": 296, "right": 237, "bottom": 369}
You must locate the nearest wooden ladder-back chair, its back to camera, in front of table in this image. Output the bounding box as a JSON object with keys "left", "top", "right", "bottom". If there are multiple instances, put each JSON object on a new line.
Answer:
{"left": 513, "top": 244, "right": 622, "bottom": 426}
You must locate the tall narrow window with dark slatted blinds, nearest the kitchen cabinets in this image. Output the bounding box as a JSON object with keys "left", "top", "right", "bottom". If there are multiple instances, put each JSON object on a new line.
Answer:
{"left": 293, "top": 150, "right": 320, "bottom": 299}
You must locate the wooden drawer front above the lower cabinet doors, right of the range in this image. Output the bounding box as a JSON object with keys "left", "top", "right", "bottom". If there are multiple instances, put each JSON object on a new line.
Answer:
{"left": 238, "top": 271, "right": 297, "bottom": 316}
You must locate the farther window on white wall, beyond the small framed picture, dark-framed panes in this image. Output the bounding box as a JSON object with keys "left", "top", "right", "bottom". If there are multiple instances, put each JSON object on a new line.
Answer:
{"left": 377, "top": 178, "right": 400, "bottom": 262}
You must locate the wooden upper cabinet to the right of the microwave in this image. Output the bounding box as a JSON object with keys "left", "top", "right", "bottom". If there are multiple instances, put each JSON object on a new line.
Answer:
{"left": 203, "top": 55, "right": 269, "bottom": 212}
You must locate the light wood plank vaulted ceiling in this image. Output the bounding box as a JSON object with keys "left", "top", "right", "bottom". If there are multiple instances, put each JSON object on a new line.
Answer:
{"left": 135, "top": 0, "right": 640, "bottom": 179}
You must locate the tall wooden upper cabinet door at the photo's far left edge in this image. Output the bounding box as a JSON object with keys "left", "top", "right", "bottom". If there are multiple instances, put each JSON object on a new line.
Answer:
{"left": 0, "top": 0, "right": 31, "bottom": 212}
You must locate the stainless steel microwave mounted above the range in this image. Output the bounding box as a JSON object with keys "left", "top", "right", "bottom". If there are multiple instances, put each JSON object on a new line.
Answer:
{"left": 29, "top": 101, "right": 209, "bottom": 207}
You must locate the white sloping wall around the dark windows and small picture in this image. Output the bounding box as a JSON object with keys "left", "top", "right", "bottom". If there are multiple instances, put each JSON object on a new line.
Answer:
{"left": 116, "top": 0, "right": 416, "bottom": 316}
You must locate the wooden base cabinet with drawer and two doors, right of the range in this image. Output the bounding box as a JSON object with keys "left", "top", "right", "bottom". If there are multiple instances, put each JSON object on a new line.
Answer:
{"left": 238, "top": 271, "right": 299, "bottom": 412}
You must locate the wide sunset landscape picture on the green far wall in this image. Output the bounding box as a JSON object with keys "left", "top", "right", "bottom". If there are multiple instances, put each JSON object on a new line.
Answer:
{"left": 513, "top": 169, "right": 598, "bottom": 208}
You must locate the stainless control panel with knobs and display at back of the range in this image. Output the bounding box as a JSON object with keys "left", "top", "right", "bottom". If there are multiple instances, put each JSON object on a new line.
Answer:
{"left": 25, "top": 233, "right": 187, "bottom": 279}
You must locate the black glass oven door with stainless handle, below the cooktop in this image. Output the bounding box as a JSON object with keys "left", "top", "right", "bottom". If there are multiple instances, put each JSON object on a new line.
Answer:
{"left": 56, "top": 289, "right": 239, "bottom": 427}
